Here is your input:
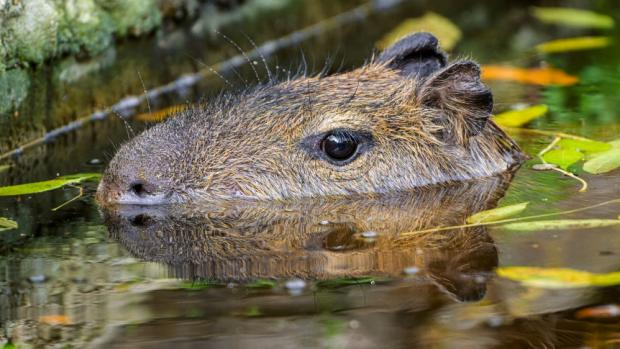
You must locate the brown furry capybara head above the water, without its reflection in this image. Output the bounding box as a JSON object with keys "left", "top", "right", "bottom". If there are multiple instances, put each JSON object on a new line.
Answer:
{"left": 97, "top": 33, "right": 523, "bottom": 205}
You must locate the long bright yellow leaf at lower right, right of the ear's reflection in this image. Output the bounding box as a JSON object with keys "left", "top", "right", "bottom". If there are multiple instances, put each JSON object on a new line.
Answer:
{"left": 495, "top": 267, "right": 620, "bottom": 288}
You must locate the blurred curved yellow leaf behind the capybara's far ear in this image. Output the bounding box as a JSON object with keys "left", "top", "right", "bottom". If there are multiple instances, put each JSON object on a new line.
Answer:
{"left": 377, "top": 12, "right": 463, "bottom": 51}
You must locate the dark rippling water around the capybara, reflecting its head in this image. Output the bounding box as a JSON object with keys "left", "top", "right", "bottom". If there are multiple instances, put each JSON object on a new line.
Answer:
{"left": 0, "top": 1, "right": 620, "bottom": 348}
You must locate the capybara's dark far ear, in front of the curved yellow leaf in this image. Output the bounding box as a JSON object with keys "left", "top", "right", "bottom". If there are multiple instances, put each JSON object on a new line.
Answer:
{"left": 377, "top": 33, "right": 447, "bottom": 80}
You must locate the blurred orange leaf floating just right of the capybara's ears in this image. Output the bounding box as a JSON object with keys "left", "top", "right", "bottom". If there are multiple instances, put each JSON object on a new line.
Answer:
{"left": 481, "top": 65, "right": 579, "bottom": 86}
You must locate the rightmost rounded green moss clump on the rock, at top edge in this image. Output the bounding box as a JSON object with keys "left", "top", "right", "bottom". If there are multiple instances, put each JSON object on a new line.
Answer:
{"left": 98, "top": 0, "right": 162, "bottom": 36}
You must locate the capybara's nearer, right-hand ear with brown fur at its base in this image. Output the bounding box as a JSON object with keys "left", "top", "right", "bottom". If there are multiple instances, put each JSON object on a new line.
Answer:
{"left": 417, "top": 61, "right": 493, "bottom": 143}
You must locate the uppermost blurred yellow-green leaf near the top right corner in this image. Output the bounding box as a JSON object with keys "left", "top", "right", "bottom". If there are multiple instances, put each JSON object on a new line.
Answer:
{"left": 531, "top": 7, "right": 614, "bottom": 29}
